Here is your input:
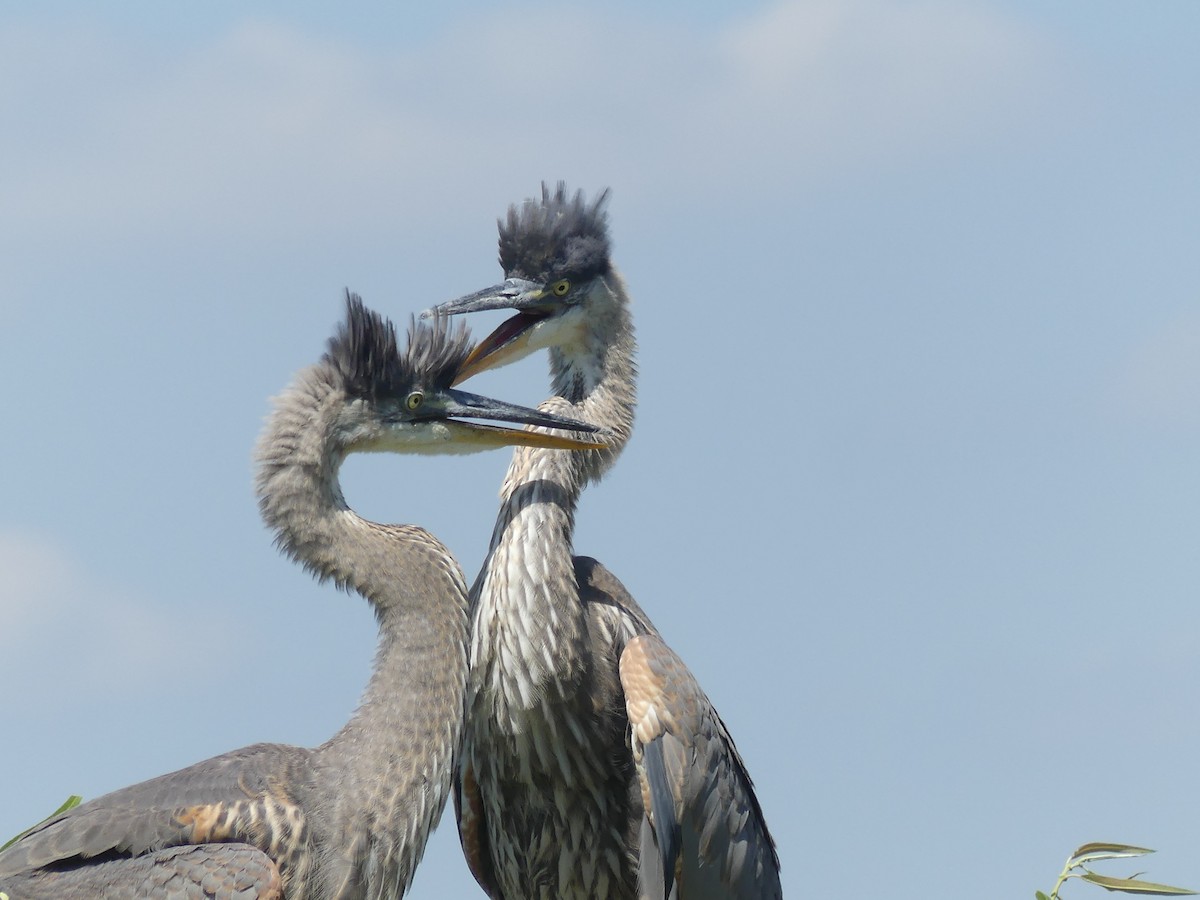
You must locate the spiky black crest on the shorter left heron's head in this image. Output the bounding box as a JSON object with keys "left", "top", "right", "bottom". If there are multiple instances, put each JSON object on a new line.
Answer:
{"left": 325, "top": 290, "right": 472, "bottom": 400}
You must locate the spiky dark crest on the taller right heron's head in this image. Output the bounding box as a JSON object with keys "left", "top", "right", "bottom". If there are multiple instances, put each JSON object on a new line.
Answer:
{"left": 499, "top": 181, "right": 610, "bottom": 282}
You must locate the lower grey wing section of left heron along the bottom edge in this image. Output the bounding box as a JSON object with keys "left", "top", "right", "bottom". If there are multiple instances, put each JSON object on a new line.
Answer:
{"left": 4, "top": 844, "right": 283, "bottom": 900}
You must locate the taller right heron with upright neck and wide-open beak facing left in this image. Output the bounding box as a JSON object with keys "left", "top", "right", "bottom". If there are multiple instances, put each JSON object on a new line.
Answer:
{"left": 427, "top": 185, "right": 781, "bottom": 900}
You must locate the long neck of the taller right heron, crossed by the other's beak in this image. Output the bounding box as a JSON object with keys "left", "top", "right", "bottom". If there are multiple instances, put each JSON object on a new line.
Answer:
{"left": 472, "top": 272, "right": 637, "bottom": 708}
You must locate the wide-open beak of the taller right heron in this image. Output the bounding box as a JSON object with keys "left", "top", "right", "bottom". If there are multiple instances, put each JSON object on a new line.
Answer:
{"left": 424, "top": 278, "right": 559, "bottom": 384}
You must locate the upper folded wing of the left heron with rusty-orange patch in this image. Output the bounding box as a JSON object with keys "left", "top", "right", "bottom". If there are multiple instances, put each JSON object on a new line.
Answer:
{"left": 0, "top": 744, "right": 307, "bottom": 877}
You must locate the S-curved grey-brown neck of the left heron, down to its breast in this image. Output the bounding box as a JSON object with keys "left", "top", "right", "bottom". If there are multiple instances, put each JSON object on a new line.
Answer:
{"left": 258, "top": 370, "right": 468, "bottom": 895}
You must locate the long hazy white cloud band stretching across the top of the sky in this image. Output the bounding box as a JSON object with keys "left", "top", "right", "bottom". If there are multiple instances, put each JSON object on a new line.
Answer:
{"left": 0, "top": 0, "right": 1049, "bottom": 247}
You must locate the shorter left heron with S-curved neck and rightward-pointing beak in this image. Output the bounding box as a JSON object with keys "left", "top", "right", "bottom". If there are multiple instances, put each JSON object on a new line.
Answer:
{"left": 0, "top": 295, "right": 596, "bottom": 900}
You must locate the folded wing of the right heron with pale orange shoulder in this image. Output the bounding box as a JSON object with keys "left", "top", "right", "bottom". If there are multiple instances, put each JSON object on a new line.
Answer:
{"left": 620, "top": 635, "right": 782, "bottom": 900}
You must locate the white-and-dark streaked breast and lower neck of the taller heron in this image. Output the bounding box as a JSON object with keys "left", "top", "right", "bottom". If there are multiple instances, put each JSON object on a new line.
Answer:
{"left": 462, "top": 376, "right": 648, "bottom": 898}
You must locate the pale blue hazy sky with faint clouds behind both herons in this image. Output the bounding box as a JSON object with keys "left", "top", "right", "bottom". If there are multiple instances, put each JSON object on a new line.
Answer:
{"left": 0, "top": 0, "right": 1200, "bottom": 900}
